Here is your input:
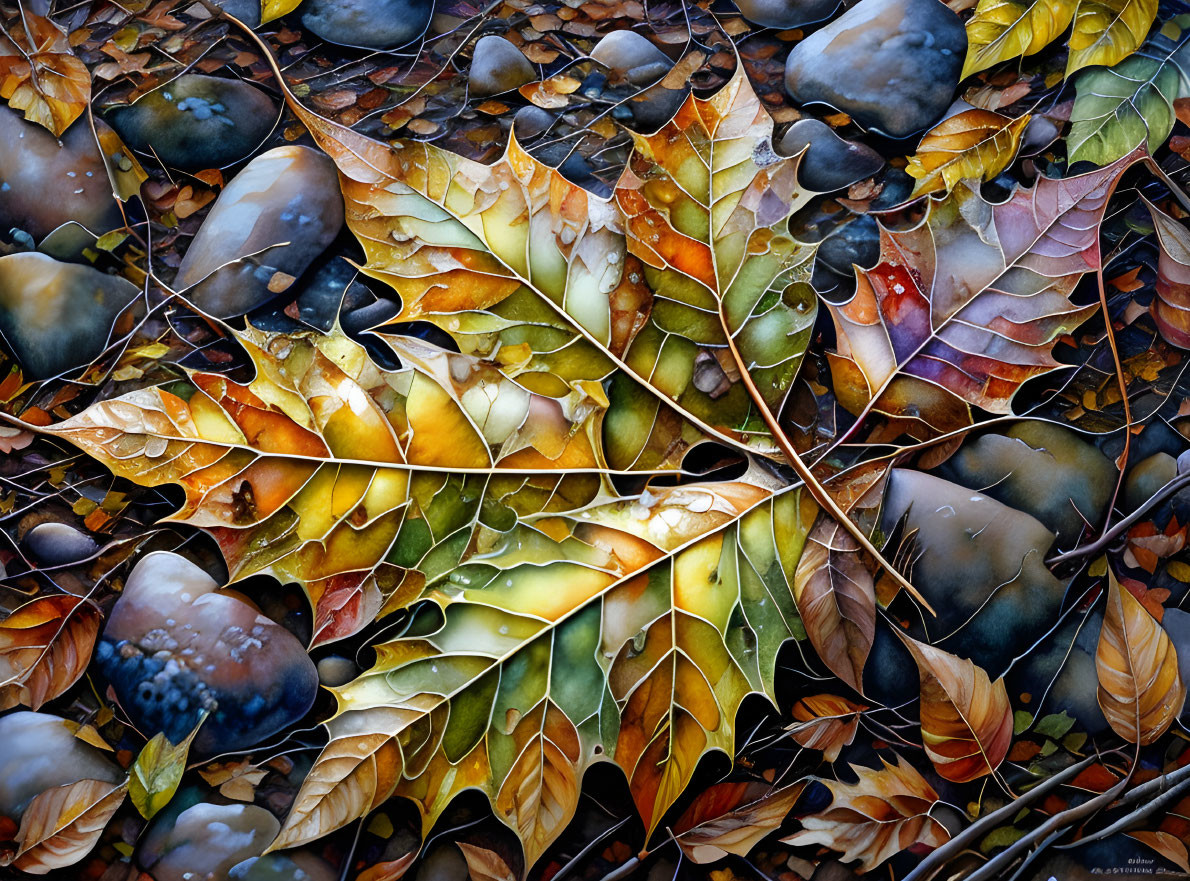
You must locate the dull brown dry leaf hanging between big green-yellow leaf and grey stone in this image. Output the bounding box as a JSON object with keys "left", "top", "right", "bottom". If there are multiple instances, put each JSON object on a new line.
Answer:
{"left": 794, "top": 517, "right": 876, "bottom": 693}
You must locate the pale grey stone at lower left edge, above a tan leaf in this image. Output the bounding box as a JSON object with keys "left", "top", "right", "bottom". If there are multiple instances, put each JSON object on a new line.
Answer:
{"left": 0, "top": 710, "right": 124, "bottom": 820}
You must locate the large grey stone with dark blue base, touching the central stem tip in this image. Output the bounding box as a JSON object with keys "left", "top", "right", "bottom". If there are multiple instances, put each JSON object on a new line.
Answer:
{"left": 882, "top": 468, "right": 1065, "bottom": 677}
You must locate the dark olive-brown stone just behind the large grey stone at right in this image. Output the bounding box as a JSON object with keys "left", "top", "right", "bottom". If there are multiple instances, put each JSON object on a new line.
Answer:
{"left": 939, "top": 421, "right": 1118, "bottom": 546}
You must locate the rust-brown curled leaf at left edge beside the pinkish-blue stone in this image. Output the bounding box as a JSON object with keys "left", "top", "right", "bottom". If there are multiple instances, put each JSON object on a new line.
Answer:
{"left": 0, "top": 594, "right": 102, "bottom": 710}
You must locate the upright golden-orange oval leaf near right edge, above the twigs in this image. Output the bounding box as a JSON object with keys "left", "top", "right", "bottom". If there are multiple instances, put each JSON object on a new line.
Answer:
{"left": 1095, "top": 570, "right": 1186, "bottom": 745}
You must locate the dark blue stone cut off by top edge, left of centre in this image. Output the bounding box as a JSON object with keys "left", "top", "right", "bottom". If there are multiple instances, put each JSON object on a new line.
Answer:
{"left": 298, "top": 0, "right": 434, "bottom": 49}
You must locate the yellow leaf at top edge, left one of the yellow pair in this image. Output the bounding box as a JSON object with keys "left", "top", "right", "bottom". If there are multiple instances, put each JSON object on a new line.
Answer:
{"left": 963, "top": 0, "right": 1076, "bottom": 79}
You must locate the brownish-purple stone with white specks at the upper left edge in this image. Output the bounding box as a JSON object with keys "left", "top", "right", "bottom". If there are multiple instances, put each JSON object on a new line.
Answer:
{"left": 0, "top": 105, "right": 124, "bottom": 240}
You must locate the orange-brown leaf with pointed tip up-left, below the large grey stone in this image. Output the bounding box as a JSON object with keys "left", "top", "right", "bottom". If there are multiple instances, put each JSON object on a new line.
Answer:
{"left": 896, "top": 630, "right": 1013, "bottom": 783}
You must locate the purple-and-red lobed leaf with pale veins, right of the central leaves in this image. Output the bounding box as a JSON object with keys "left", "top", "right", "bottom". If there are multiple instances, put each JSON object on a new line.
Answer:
{"left": 827, "top": 154, "right": 1138, "bottom": 431}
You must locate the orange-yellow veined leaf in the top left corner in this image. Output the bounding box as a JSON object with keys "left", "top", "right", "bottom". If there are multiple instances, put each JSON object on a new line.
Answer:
{"left": 0, "top": 8, "right": 90, "bottom": 135}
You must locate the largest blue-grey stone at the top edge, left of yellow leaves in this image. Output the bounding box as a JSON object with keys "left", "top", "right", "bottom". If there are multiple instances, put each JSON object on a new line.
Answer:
{"left": 785, "top": 0, "right": 966, "bottom": 138}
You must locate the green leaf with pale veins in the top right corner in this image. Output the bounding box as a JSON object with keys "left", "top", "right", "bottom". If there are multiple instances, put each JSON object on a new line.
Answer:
{"left": 1067, "top": 15, "right": 1190, "bottom": 165}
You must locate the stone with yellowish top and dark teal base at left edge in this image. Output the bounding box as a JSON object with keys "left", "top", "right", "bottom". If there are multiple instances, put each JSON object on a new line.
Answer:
{"left": 0, "top": 252, "right": 140, "bottom": 380}
